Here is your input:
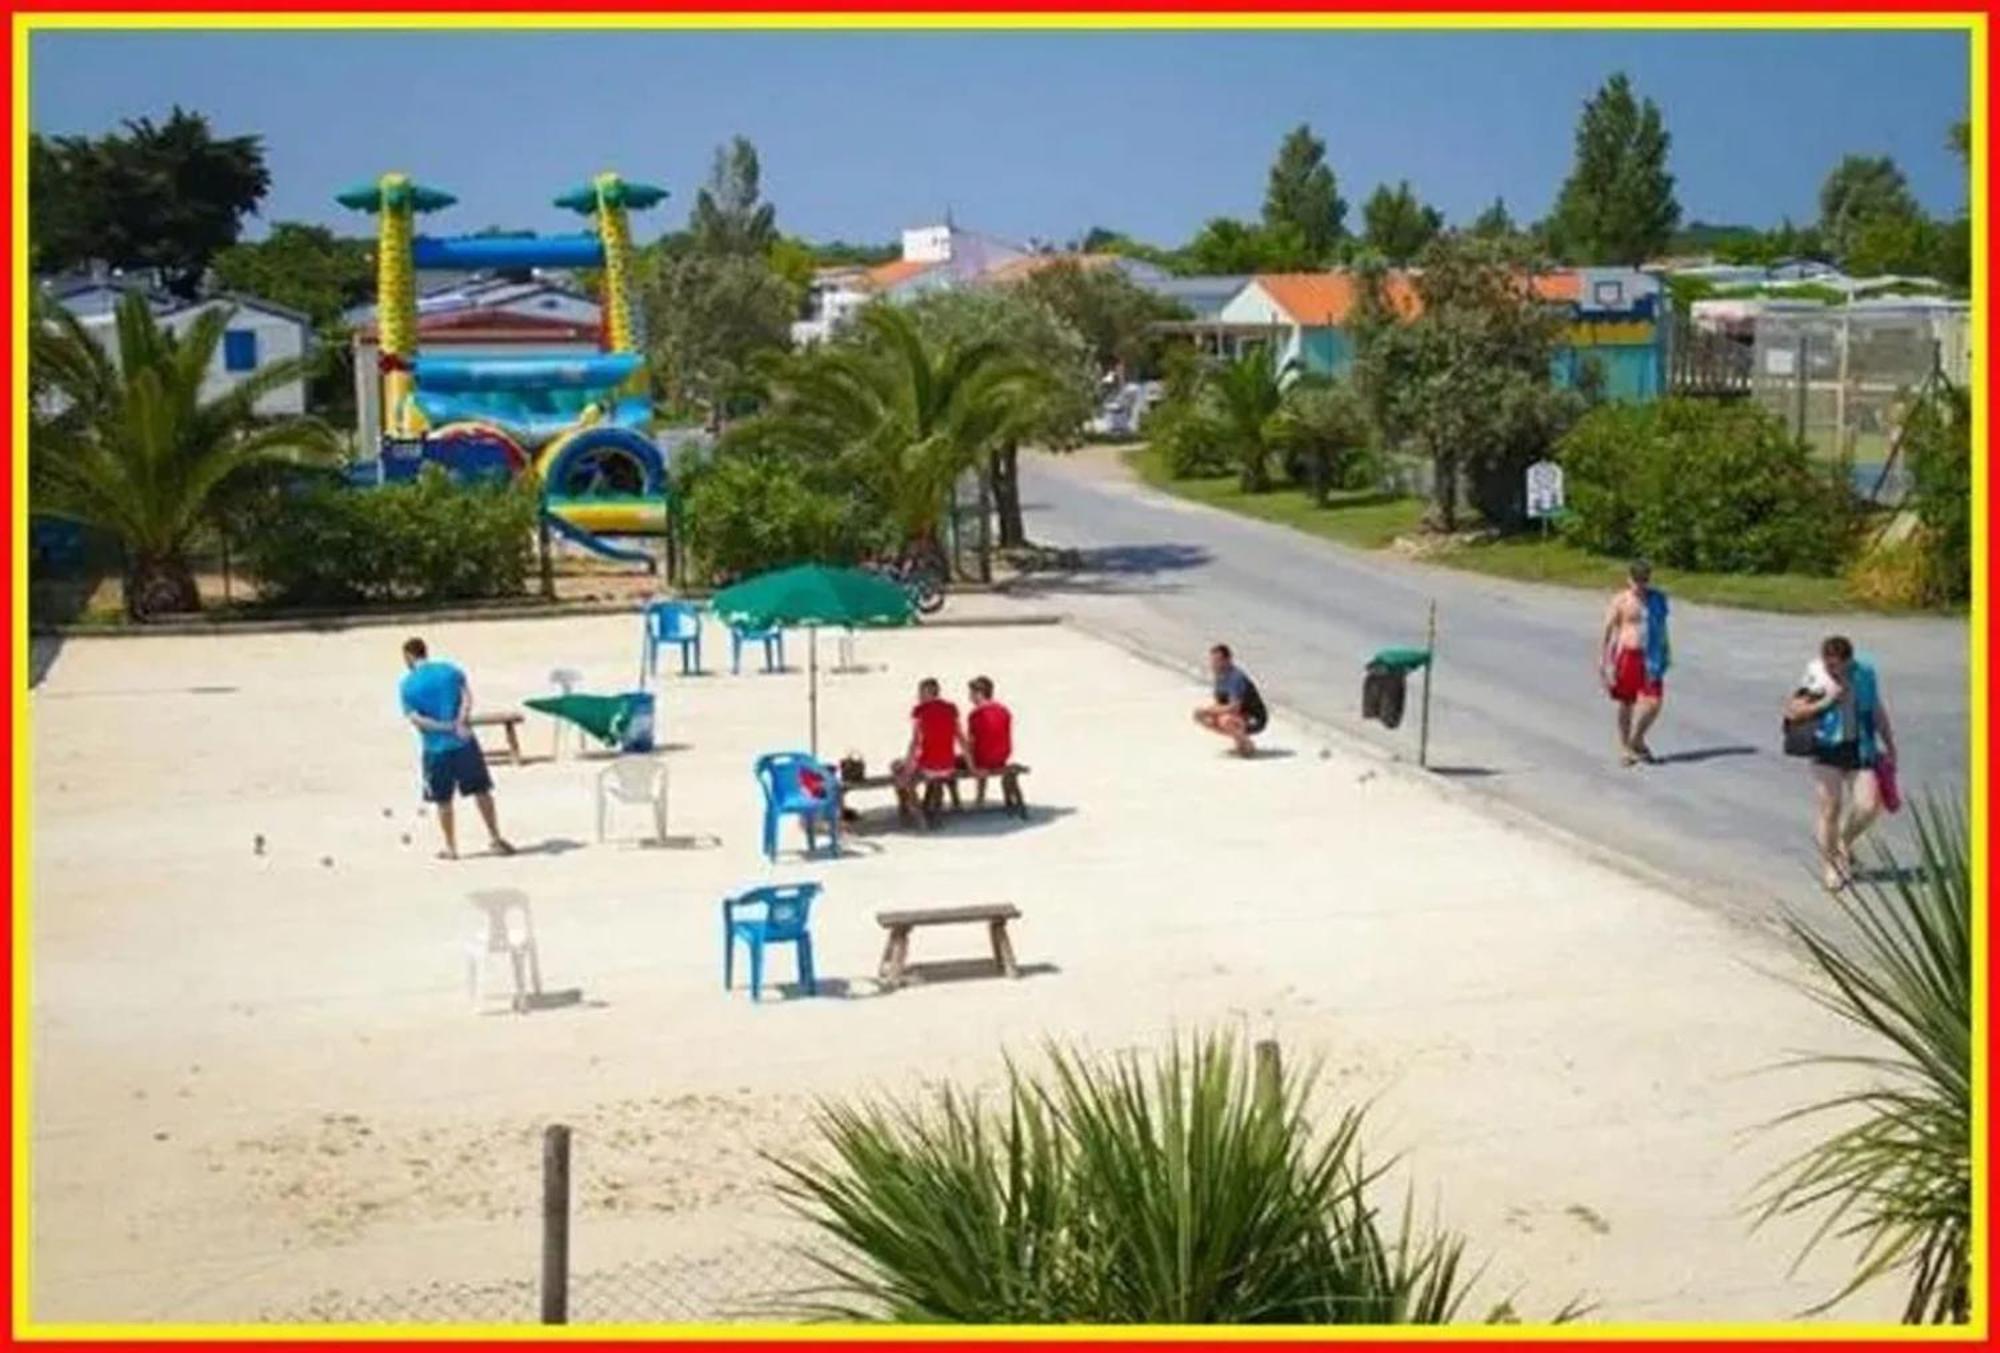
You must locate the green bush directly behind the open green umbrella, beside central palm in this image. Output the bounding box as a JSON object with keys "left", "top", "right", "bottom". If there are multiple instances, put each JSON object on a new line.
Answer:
{"left": 686, "top": 452, "right": 886, "bottom": 578}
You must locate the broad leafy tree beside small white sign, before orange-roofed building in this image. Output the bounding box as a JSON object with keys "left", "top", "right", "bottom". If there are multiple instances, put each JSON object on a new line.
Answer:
{"left": 1354, "top": 236, "right": 1584, "bottom": 530}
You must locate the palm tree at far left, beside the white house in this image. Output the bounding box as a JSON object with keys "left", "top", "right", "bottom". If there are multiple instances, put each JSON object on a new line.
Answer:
{"left": 30, "top": 294, "right": 338, "bottom": 618}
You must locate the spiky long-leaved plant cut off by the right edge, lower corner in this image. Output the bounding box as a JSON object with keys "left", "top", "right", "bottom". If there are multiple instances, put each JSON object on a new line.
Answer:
{"left": 1758, "top": 803, "right": 1972, "bottom": 1325}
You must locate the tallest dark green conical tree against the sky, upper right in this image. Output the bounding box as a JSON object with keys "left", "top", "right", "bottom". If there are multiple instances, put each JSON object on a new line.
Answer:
{"left": 1550, "top": 72, "right": 1680, "bottom": 266}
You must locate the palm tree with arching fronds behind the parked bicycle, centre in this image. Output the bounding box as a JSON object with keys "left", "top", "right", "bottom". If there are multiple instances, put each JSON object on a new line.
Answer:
{"left": 746, "top": 306, "right": 1038, "bottom": 556}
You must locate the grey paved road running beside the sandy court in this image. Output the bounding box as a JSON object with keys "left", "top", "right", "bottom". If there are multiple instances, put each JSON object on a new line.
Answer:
{"left": 1022, "top": 452, "right": 1970, "bottom": 936}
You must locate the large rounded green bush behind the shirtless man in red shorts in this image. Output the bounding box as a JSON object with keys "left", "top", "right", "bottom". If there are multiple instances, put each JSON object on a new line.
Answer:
{"left": 1556, "top": 398, "right": 1858, "bottom": 574}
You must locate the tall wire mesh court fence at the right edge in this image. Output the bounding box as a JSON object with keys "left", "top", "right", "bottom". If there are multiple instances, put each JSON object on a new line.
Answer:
{"left": 1750, "top": 306, "right": 1972, "bottom": 502}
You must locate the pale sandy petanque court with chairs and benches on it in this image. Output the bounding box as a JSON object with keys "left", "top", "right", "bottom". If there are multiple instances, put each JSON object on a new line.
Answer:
{"left": 30, "top": 602, "right": 1890, "bottom": 1321}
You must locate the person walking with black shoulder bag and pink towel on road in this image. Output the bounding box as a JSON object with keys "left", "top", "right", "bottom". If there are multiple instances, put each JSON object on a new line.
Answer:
{"left": 1784, "top": 634, "right": 1896, "bottom": 891}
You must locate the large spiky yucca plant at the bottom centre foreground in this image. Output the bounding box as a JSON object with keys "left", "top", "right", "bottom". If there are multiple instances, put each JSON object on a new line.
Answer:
{"left": 774, "top": 1037, "right": 1504, "bottom": 1325}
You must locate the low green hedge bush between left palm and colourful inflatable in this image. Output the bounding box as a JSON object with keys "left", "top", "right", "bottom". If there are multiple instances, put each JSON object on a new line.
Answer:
{"left": 244, "top": 466, "right": 536, "bottom": 606}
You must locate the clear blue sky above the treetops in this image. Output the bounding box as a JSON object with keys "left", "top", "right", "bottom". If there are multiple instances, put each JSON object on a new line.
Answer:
{"left": 30, "top": 32, "right": 1970, "bottom": 244}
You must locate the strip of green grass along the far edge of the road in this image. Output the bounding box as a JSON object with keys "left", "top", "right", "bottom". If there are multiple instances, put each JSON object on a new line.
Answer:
{"left": 1124, "top": 446, "right": 1868, "bottom": 614}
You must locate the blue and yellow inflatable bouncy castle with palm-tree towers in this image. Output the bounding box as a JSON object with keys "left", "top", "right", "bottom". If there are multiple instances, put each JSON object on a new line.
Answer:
{"left": 336, "top": 174, "right": 666, "bottom": 566}
